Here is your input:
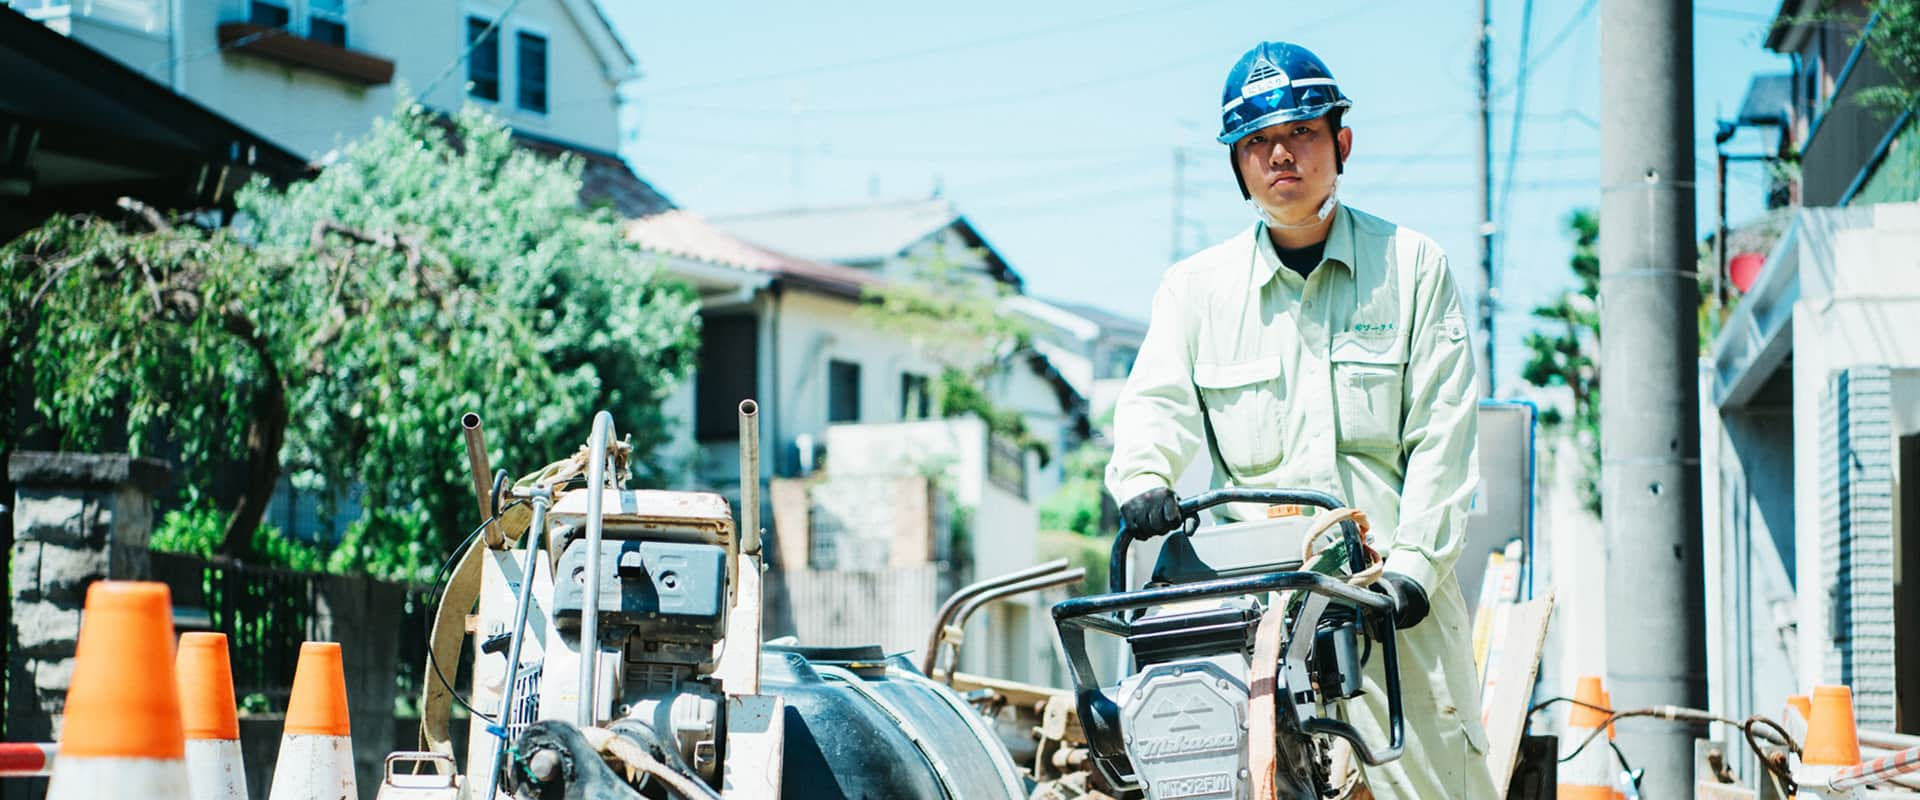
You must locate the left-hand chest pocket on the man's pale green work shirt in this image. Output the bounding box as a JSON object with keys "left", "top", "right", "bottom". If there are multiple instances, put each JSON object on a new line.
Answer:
{"left": 1194, "top": 355, "right": 1286, "bottom": 476}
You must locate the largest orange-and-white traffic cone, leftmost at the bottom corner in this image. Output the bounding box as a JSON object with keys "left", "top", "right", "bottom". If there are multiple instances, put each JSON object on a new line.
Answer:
{"left": 46, "top": 581, "right": 188, "bottom": 800}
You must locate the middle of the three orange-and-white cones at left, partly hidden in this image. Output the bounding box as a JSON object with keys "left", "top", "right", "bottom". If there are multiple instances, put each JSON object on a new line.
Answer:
{"left": 175, "top": 633, "right": 246, "bottom": 800}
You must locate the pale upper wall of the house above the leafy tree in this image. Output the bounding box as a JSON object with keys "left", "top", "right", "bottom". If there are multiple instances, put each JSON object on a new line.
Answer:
{"left": 60, "top": 0, "right": 620, "bottom": 159}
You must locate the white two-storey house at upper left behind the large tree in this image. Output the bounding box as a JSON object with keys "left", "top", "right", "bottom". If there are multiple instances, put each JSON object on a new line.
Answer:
{"left": 12, "top": 0, "right": 691, "bottom": 539}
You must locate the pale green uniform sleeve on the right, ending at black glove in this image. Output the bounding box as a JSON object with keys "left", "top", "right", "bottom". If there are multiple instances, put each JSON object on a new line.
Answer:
{"left": 1386, "top": 253, "right": 1480, "bottom": 593}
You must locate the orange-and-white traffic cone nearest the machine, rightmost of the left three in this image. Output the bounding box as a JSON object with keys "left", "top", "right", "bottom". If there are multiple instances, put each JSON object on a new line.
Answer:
{"left": 267, "top": 641, "right": 359, "bottom": 800}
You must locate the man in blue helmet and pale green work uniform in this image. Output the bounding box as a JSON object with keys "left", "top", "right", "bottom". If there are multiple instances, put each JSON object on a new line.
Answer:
{"left": 1106, "top": 42, "right": 1496, "bottom": 800}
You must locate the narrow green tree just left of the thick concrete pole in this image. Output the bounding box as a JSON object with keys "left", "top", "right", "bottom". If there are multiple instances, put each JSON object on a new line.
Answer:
{"left": 1521, "top": 209, "right": 1599, "bottom": 514}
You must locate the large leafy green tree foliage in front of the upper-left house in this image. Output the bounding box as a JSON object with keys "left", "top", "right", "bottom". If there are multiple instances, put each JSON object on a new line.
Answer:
{"left": 0, "top": 102, "right": 697, "bottom": 574}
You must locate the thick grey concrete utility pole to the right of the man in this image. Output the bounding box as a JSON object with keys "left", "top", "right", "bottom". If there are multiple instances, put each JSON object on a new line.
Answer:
{"left": 1599, "top": 0, "right": 1707, "bottom": 798}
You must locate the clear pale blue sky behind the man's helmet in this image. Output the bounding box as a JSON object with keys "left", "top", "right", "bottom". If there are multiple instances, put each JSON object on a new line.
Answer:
{"left": 603, "top": 0, "right": 1788, "bottom": 389}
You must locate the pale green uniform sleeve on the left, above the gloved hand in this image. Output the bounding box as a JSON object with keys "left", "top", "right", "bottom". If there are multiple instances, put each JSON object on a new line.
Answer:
{"left": 1106, "top": 274, "right": 1206, "bottom": 503}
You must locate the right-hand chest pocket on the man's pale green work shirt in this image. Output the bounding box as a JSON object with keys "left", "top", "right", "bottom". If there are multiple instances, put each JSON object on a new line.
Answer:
{"left": 1332, "top": 334, "right": 1407, "bottom": 451}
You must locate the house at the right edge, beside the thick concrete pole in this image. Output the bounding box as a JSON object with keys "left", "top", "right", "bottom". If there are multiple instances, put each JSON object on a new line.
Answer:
{"left": 1701, "top": 2, "right": 1920, "bottom": 763}
